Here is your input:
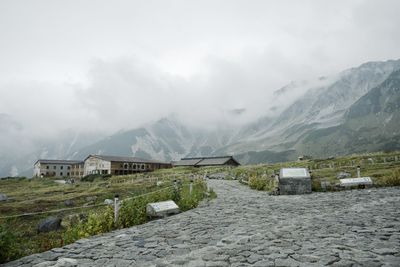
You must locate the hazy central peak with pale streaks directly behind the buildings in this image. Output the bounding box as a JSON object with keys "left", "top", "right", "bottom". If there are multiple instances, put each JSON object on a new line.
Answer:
{"left": 70, "top": 118, "right": 236, "bottom": 161}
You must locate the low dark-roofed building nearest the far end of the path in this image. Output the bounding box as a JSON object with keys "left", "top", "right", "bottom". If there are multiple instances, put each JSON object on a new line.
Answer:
{"left": 173, "top": 156, "right": 240, "bottom": 167}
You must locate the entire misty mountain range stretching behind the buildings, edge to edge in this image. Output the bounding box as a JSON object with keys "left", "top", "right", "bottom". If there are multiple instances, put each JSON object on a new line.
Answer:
{"left": 0, "top": 60, "right": 400, "bottom": 177}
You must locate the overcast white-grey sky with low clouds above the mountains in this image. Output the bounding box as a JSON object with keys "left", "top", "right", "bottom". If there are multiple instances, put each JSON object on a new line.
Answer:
{"left": 0, "top": 0, "right": 400, "bottom": 138}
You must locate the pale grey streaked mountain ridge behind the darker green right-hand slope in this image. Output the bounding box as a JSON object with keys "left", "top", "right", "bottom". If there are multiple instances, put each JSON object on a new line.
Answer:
{"left": 220, "top": 60, "right": 400, "bottom": 156}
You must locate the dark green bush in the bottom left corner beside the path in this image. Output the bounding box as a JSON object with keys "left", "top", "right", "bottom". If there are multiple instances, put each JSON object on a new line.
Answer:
{"left": 0, "top": 225, "right": 20, "bottom": 263}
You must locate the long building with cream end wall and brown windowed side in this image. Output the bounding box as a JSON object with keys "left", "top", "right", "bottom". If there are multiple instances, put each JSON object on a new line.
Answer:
{"left": 84, "top": 155, "right": 172, "bottom": 175}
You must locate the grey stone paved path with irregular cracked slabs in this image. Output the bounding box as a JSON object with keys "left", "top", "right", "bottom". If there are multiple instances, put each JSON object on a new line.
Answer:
{"left": 6, "top": 181, "right": 400, "bottom": 267}
